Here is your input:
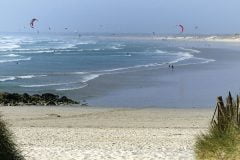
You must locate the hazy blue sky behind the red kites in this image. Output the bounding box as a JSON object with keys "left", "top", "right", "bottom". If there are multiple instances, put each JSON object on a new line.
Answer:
{"left": 0, "top": 0, "right": 240, "bottom": 34}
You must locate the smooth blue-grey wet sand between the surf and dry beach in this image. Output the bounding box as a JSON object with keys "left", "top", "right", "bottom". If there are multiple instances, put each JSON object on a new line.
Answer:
{"left": 72, "top": 48, "right": 240, "bottom": 107}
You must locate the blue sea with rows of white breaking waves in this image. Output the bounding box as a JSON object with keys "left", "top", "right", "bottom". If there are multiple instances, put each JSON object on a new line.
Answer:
{"left": 0, "top": 33, "right": 238, "bottom": 106}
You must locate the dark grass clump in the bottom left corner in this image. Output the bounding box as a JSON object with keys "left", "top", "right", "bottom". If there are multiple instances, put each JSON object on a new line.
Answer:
{"left": 0, "top": 117, "right": 24, "bottom": 160}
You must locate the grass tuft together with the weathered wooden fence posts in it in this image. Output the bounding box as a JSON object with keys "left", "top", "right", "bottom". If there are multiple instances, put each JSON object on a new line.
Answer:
{"left": 195, "top": 92, "right": 240, "bottom": 160}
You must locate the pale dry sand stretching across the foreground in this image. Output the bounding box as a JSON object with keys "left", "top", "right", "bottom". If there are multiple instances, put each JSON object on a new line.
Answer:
{"left": 0, "top": 107, "right": 213, "bottom": 160}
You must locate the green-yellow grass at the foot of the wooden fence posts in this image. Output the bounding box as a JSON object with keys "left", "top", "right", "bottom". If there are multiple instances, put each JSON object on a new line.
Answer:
{"left": 195, "top": 126, "right": 240, "bottom": 160}
